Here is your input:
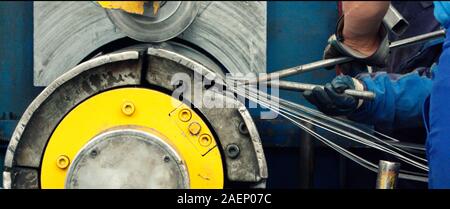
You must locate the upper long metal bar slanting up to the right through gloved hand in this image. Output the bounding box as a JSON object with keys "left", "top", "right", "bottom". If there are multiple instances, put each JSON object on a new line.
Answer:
{"left": 243, "top": 29, "right": 445, "bottom": 84}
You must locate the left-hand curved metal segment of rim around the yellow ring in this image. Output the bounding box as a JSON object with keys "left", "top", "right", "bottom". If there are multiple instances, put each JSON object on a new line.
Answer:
{"left": 5, "top": 51, "right": 140, "bottom": 178}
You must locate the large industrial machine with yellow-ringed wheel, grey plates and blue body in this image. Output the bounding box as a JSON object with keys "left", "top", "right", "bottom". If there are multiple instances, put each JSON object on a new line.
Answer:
{"left": 0, "top": 1, "right": 430, "bottom": 189}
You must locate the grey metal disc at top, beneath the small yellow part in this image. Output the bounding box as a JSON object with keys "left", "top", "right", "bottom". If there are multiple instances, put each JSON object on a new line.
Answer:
{"left": 106, "top": 1, "right": 198, "bottom": 42}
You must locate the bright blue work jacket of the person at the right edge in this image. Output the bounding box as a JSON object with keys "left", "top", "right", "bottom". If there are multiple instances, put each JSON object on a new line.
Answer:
{"left": 349, "top": 2, "right": 450, "bottom": 189}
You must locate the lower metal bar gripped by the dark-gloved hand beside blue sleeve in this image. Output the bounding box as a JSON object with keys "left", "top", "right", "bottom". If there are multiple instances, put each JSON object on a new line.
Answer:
{"left": 269, "top": 81, "right": 375, "bottom": 100}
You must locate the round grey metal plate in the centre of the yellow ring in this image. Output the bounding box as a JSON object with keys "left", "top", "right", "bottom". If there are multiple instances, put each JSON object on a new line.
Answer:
{"left": 66, "top": 129, "right": 189, "bottom": 189}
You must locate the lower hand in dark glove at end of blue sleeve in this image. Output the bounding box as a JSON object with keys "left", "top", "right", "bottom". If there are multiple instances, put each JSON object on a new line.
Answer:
{"left": 303, "top": 75, "right": 364, "bottom": 116}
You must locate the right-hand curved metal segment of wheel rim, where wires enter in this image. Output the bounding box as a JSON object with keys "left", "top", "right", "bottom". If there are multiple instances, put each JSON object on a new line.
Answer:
{"left": 146, "top": 43, "right": 268, "bottom": 182}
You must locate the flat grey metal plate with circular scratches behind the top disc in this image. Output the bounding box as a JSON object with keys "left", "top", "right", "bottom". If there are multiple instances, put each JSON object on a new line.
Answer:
{"left": 34, "top": 1, "right": 267, "bottom": 86}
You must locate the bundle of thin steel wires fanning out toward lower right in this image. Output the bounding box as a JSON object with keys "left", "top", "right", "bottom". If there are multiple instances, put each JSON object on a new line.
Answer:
{"left": 216, "top": 82, "right": 428, "bottom": 182}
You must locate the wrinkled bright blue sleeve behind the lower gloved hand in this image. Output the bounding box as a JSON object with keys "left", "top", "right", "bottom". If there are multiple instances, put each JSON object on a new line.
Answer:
{"left": 349, "top": 71, "right": 431, "bottom": 130}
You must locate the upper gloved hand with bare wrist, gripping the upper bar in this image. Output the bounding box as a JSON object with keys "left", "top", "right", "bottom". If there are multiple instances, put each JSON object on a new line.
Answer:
{"left": 323, "top": 18, "right": 389, "bottom": 75}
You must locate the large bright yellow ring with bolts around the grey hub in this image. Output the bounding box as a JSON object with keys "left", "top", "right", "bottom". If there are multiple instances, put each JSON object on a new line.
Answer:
{"left": 41, "top": 88, "right": 224, "bottom": 188}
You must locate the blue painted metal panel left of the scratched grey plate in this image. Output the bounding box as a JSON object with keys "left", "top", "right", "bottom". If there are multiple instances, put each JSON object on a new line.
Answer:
{"left": 0, "top": 1, "right": 42, "bottom": 183}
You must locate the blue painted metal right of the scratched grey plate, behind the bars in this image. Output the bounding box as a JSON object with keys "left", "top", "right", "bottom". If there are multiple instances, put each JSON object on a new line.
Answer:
{"left": 250, "top": 1, "right": 338, "bottom": 147}
